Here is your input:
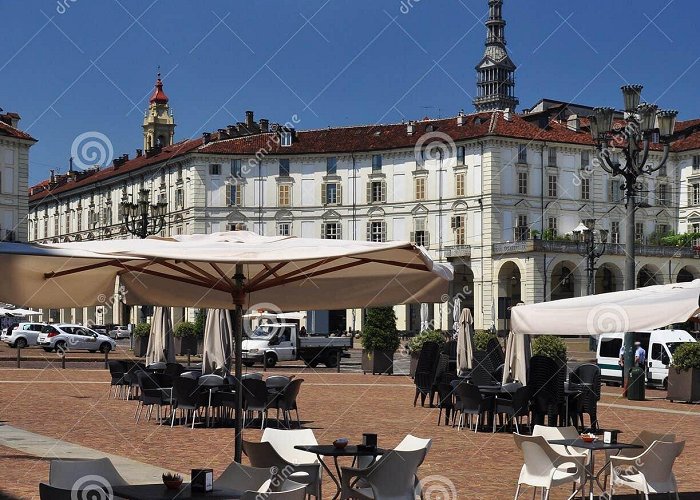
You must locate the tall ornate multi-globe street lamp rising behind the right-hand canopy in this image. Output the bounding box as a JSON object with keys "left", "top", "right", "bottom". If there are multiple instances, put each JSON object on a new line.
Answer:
{"left": 590, "top": 85, "right": 678, "bottom": 396}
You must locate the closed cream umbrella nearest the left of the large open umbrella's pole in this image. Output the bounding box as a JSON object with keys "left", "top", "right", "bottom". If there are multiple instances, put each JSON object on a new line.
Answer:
{"left": 202, "top": 309, "right": 234, "bottom": 375}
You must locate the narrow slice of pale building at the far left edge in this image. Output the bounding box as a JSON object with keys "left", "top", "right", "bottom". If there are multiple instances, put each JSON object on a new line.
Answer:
{"left": 0, "top": 110, "right": 36, "bottom": 241}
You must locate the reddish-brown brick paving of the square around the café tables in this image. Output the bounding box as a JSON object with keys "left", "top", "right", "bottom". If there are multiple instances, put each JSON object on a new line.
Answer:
{"left": 0, "top": 368, "right": 700, "bottom": 499}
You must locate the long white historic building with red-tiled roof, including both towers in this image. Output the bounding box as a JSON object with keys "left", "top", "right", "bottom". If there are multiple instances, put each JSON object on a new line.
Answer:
{"left": 29, "top": 0, "right": 700, "bottom": 332}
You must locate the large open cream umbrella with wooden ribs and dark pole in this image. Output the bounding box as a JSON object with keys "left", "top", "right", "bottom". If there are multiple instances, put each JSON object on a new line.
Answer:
{"left": 0, "top": 231, "right": 453, "bottom": 461}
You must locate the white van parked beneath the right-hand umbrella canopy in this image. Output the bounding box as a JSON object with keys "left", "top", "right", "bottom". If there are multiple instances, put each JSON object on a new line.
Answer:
{"left": 597, "top": 330, "right": 696, "bottom": 388}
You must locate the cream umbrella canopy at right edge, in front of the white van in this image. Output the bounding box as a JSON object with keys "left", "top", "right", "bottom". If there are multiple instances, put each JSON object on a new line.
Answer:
{"left": 510, "top": 280, "right": 700, "bottom": 335}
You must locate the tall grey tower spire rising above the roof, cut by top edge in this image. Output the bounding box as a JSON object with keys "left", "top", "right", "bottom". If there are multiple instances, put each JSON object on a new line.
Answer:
{"left": 474, "top": 0, "right": 518, "bottom": 111}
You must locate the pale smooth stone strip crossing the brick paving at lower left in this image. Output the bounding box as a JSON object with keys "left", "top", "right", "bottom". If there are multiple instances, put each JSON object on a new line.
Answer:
{"left": 0, "top": 425, "right": 174, "bottom": 484}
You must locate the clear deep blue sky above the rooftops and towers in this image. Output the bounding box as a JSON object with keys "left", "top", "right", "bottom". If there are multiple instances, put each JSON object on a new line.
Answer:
{"left": 0, "top": 0, "right": 700, "bottom": 183}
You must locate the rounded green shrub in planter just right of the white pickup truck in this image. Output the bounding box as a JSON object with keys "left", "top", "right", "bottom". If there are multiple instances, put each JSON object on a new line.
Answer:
{"left": 362, "top": 307, "right": 400, "bottom": 375}
